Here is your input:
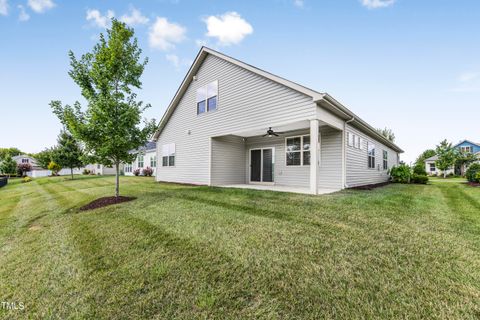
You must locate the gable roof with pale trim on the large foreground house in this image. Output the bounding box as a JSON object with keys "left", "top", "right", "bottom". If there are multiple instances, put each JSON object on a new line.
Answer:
{"left": 153, "top": 46, "right": 403, "bottom": 152}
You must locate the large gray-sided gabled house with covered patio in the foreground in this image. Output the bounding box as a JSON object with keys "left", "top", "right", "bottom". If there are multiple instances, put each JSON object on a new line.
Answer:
{"left": 154, "top": 47, "right": 403, "bottom": 194}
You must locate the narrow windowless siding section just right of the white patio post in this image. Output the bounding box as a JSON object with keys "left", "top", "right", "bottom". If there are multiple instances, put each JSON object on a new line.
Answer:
{"left": 318, "top": 129, "right": 343, "bottom": 189}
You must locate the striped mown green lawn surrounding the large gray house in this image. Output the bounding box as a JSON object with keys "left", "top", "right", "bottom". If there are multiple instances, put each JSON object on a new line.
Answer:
{"left": 0, "top": 177, "right": 480, "bottom": 319}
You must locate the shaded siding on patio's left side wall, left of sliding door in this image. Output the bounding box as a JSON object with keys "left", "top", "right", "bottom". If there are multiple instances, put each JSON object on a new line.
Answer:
{"left": 211, "top": 136, "right": 246, "bottom": 186}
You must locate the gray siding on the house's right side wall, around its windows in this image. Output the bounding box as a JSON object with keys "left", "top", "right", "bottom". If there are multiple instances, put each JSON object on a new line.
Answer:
{"left": 345, "top": 125, "right": 398, "bottom": 187}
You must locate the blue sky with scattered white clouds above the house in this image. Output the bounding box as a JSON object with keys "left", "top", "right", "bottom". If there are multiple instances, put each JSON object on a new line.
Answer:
{"left": 0, "top": 0, "right": 480, "bottom": 163}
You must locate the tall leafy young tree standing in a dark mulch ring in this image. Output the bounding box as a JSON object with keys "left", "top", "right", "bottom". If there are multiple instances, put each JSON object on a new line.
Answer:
{"left": 50, "top": 19, "right": 156, "bottom": 197}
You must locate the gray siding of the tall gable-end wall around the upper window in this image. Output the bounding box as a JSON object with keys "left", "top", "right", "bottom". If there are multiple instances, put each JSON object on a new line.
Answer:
{"left": 156, "top": 55, "right": 317, "bottom": 184}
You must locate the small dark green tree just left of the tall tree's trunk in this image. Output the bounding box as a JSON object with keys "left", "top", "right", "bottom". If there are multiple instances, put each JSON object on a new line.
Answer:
{"left": 52, "top": 130, "right": 83, "bottom": 180}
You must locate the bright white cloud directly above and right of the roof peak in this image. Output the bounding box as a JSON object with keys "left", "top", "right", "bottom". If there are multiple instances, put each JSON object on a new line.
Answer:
{"left": 204, "top": 12, "right": 253, "bottom": 46}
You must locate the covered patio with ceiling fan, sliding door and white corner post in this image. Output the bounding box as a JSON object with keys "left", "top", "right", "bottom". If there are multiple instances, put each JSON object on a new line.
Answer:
{"left": 210, "top": 119, "right": 344, "bottom": 194}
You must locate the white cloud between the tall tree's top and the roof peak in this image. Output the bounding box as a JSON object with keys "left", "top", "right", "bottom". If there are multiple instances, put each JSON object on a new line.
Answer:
{"left": 148, "top": 17, "right": 187, "bottom": 51}
